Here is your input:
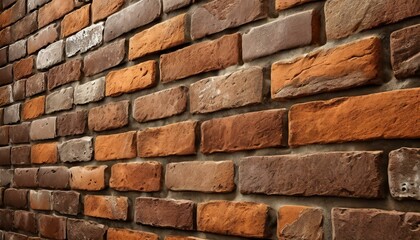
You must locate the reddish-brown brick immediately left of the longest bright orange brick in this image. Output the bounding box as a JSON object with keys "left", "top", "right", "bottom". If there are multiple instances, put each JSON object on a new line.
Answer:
{"left": 201, "top": 109, "right": 286, "bottom": 154}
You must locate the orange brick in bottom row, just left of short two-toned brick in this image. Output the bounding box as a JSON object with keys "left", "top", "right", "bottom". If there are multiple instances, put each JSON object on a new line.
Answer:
{"left": 197, "top": 201, "right": 269, "bottom": 238}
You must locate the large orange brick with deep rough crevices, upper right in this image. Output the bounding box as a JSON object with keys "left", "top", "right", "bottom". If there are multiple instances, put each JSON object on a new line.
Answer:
{"left": 271, "top": 37, "right": 381, "bottom": 99}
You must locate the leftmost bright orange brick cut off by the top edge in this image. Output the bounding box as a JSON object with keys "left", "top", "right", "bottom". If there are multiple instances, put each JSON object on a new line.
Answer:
{"left": 38, "top": 0, "right": 75, "bottom": 28}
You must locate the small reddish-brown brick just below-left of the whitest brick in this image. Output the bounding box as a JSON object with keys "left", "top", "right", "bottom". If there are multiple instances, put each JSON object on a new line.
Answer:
{"left": 47, "top": 59, "right": 82, "bottom": 90}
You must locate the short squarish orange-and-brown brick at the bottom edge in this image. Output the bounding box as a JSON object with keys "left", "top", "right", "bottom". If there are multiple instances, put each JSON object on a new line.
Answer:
{"left": 277, "top": 206, "right": 324, "bottom": 240}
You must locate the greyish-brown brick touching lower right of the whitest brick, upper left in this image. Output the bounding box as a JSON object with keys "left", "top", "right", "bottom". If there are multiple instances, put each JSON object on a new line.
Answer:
{"left": 83, "top": 39, "right": 125, "bottom": 76}
